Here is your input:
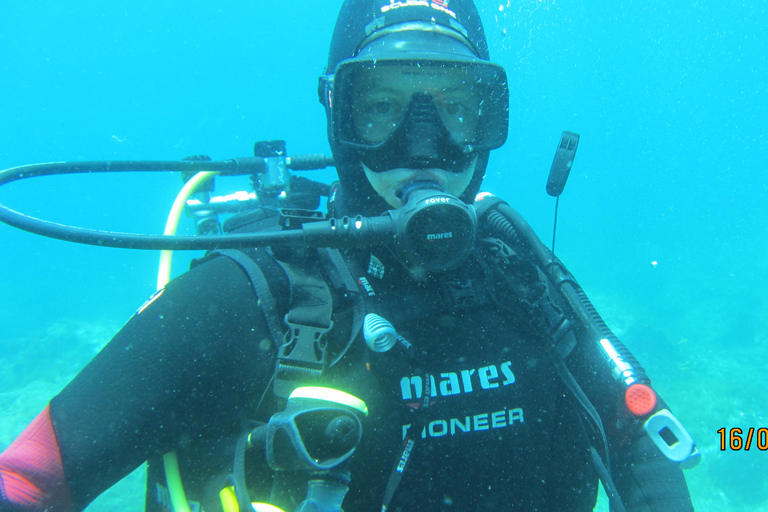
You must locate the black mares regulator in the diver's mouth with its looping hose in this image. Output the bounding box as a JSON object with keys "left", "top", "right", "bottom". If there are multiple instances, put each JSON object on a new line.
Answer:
{"left": 0, "top": 141, "right": 477, "bottom": 272}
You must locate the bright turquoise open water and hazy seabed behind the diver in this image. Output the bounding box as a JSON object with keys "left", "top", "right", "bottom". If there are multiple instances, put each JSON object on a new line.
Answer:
{"left": 0, "top": 0, "right": 768, "bottom": 512}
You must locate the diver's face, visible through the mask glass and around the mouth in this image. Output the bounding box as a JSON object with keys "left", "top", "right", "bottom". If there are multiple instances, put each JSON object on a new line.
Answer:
{"left": 352, "top": 65, "right": 480, "bottom": 208}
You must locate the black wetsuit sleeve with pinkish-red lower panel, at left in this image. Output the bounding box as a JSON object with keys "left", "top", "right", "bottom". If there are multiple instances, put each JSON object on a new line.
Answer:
{"left": 0, "top": 257, "right": 273, "bottom": 512}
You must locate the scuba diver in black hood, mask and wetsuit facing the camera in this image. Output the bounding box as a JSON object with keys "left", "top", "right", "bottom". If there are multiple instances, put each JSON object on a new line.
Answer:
{"left": 0, "top": 0, "right": 693, "bottom": 512}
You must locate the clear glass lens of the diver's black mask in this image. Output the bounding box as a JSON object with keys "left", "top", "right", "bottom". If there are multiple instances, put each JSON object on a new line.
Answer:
{"left": 333, "top": 60, "right": 509, "bottom": 149}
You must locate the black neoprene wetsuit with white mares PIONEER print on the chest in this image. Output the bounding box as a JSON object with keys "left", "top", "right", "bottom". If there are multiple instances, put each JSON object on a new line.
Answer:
{"left": 0, "top": 231, "right": 692, "bottom": 512}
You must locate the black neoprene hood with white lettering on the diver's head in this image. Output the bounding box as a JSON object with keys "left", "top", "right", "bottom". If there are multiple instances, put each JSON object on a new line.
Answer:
{"left": 319, "top": 0, "right": 498, "bottom": 215}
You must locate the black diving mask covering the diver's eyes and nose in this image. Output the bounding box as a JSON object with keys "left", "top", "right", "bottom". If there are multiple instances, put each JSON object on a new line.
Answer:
{"left": 326, "top": 55, "right": 509, "bottom": 172}
